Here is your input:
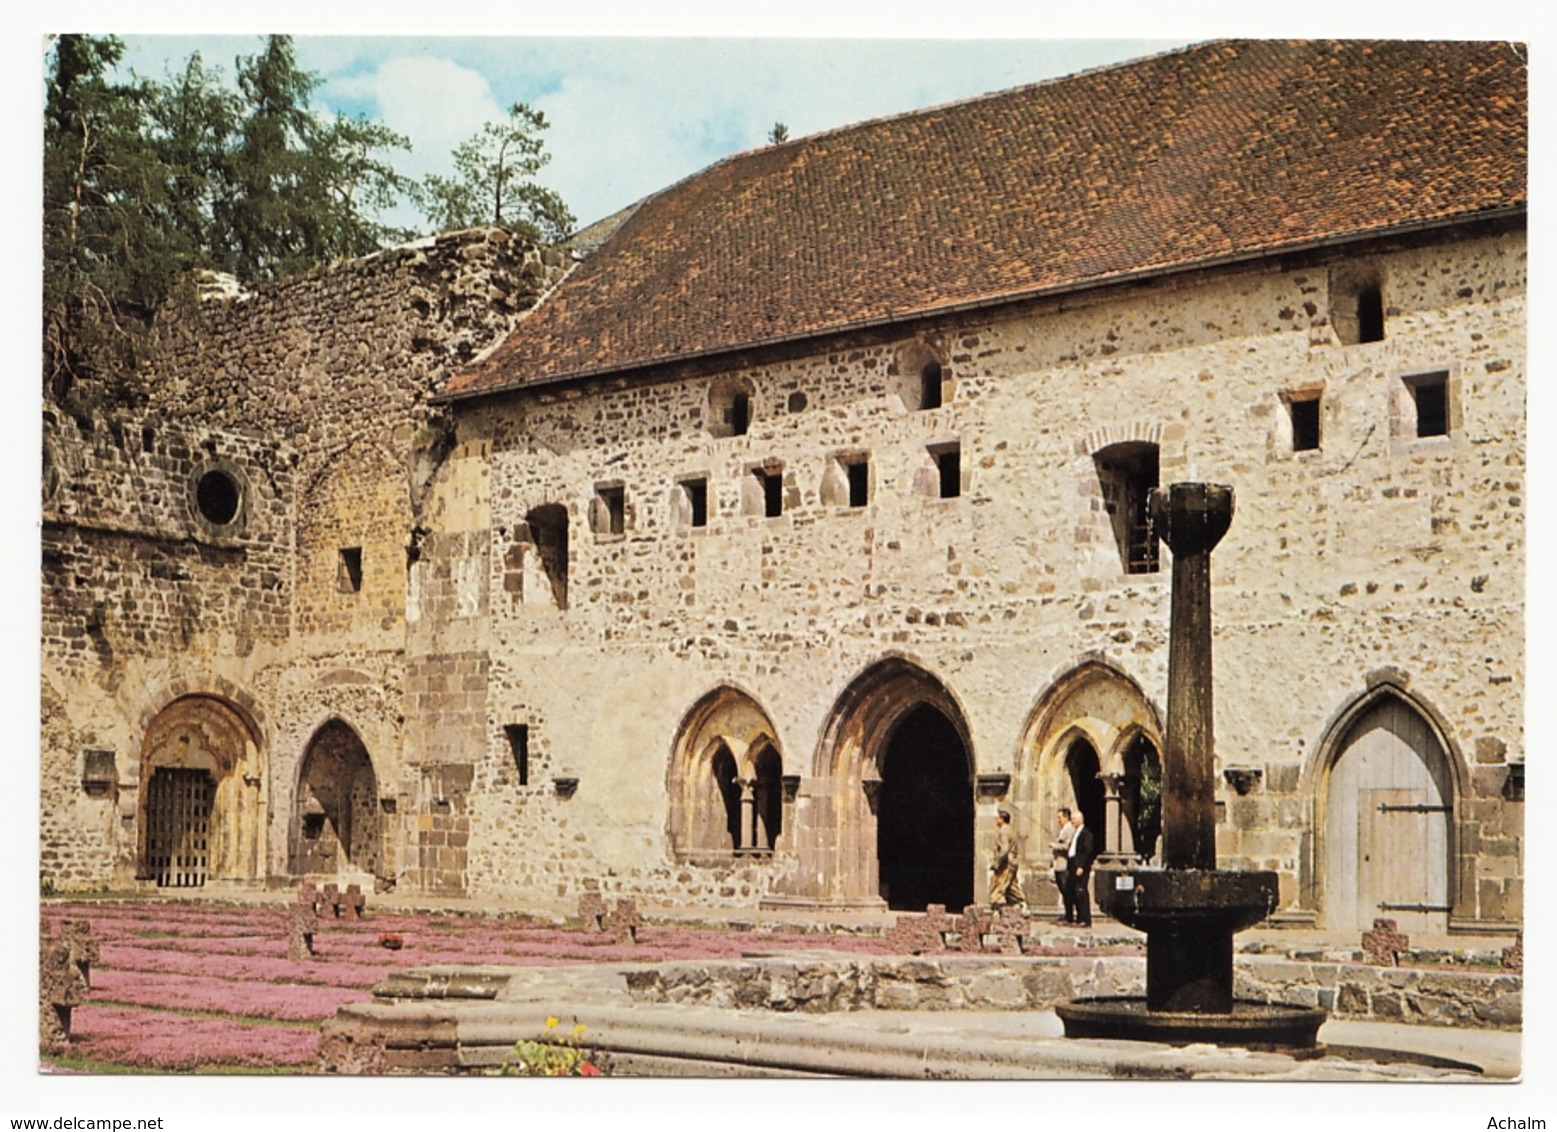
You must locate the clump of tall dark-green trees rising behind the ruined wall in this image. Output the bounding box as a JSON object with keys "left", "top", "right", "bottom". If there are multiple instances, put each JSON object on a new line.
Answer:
{"left": 44, "top": 36, "right": 417, "bottom": 399}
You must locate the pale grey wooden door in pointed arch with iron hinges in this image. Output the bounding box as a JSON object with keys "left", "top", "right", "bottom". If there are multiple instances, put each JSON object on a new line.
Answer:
{"left": 1322, "top": 698, "right": 1453, "bottom": 934}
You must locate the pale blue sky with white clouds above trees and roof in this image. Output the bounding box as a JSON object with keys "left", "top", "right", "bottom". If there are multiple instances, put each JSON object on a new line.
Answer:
{"left": 112, "top": 34, "right": 1188, "bottom": 232}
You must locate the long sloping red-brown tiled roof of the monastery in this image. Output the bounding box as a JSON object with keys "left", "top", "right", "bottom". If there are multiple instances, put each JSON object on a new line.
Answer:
{"left": 445, "top": 40, "right": 1527, "bottom": 397}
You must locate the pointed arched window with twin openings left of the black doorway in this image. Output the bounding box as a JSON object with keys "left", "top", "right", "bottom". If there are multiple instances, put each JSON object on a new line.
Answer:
{"left": 665, "top": 684, "right": 783, "bottom": 864}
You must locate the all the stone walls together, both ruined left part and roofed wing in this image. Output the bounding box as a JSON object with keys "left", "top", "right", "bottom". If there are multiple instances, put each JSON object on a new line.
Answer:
{"left": 42, "top": 216, "right": 1526, "bottom": 925}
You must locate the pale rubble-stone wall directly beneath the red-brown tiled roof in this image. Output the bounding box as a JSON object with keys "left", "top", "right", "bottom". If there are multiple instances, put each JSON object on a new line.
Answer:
{"left": 434, "top": 225, "right": 1524, "bottom": 920}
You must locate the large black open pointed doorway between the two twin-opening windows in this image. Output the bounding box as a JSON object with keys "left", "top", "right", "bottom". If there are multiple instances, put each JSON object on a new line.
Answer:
{"left": 877, "top": 704, "right": 973, "bottom": 911}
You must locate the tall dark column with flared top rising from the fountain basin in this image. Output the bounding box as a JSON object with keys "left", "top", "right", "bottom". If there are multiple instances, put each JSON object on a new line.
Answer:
{"left": 1151, "top": 483, "right": 1233, "bottom": 869}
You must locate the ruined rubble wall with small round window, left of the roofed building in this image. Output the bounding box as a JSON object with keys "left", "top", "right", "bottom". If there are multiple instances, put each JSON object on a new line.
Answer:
{"left": 42, "top": 229, "right": 565, "bottom": 888}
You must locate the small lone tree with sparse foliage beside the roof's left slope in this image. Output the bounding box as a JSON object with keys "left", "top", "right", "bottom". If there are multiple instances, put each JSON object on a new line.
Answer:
{"left": 422, "top": 103, "right": 575, "bottom": 241}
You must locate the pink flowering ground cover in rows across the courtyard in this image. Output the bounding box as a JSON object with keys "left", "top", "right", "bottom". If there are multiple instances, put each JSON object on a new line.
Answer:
{"left": 40, "top": 900, "right": 884, "bottom": 1073}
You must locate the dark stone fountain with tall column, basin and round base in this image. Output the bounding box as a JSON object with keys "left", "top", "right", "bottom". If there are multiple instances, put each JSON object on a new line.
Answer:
{"left": 1057, "top": 483, "right": 1325, "bottom": 1046}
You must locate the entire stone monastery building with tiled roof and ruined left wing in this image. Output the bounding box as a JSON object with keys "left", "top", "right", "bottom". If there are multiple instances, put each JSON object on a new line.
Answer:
{"left": 42, "top": 42, "right": 1526, "bottom": 931}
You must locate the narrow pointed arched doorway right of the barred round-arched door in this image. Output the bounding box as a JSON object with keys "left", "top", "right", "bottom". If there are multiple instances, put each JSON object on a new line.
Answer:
{"left": 291, "top": 719, "right": 380, "bottom": 875}
